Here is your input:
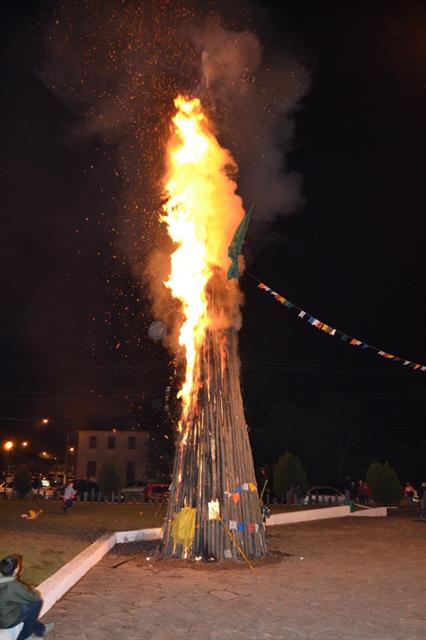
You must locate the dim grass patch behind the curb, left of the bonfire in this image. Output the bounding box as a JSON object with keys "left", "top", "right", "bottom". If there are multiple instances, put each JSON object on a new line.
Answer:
{"left": 0, "top": 500, "right": 166, "bottom": 586}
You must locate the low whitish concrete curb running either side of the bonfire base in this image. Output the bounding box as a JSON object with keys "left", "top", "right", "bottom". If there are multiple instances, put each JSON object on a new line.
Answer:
{"left": 0, "top": 506, "right": 387, "bottom": 640}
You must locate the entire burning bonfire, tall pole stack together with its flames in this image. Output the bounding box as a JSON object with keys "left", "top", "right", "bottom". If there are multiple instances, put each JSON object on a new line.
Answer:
{"left": 161, "top": 96, "right": 267, "bottom": 560}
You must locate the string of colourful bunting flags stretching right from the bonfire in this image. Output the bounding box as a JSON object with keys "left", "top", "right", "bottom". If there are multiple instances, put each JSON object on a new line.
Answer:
{"left": 250, "top": 271, "right": 426, "bottom": 373}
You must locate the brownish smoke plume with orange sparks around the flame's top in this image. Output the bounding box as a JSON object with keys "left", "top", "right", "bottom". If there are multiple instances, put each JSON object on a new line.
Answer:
{"left": 43, "top": 0, "right": 309, "bottom": 340}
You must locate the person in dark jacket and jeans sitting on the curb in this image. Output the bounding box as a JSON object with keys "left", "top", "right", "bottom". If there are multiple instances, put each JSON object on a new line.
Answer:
{"left": 0, "top": 555, "right": 54, "bottom": 640}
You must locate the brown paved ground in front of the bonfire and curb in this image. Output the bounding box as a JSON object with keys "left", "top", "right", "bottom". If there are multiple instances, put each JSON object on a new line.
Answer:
{"left": 45, "top": 516, "right": 426, "bottom": 640}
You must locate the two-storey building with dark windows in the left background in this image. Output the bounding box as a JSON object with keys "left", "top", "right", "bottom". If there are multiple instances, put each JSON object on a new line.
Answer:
{"left": 75, "top": 429, "right": 150, "bottom": 484}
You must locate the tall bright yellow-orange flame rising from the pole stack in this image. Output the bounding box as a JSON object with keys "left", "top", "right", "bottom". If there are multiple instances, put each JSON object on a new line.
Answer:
{"left": 161, "top": 96, "right": 244, "bottom": 418}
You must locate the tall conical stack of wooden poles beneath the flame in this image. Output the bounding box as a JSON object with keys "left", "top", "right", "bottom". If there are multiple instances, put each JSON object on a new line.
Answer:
{"left": 163, "top": 276, "right": 267, "bottom": 560}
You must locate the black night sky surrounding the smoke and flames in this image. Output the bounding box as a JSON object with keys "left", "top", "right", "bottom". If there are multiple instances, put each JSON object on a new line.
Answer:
{"left": 0, "top": 0, "right": 426, "bottom": 481}
